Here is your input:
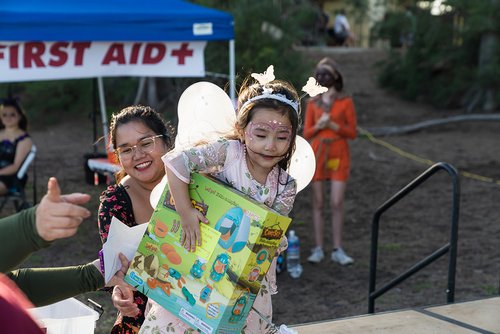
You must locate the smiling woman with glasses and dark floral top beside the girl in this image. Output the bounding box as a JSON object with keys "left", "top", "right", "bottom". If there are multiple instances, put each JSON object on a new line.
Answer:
{"left": 98, "top": 106, "right": 173, "bottom": 333}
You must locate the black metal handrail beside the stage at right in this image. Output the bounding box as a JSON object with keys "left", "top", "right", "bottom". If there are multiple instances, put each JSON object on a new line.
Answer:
{"left": 368, "top": 162, "right": 460, "bottom": 313}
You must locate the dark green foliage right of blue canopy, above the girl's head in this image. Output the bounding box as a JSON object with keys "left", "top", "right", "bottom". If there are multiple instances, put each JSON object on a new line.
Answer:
{"left": 195, "top": 0, "right": 316, "bottom": 87}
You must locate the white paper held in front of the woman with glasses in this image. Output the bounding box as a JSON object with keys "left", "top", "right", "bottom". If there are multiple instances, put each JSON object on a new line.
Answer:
{"left": 102, "top": 217, "right": 148, "bottom": 284}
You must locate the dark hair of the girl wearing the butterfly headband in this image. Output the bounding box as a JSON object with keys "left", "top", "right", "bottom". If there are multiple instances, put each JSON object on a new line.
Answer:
{"left": 230, "top": 77, "right": 300, "bottom": 170}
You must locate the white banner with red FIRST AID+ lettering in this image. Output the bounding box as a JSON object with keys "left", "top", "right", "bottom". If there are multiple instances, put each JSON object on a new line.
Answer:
{"left": 0, "top": 41, "right": 206, "bottom": 82}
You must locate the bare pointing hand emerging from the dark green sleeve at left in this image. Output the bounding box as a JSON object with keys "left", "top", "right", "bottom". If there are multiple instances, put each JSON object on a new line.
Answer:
{"left": 36, "top": 177, "right": 90, "bottom": 241}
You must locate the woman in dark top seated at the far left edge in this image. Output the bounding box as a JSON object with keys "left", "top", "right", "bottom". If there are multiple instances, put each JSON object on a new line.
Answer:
{"left": 0, "top": 98, "right": 33, "bottom": 195}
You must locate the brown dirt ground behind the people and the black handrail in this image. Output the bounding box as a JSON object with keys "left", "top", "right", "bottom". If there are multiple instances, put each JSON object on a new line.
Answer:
{"left": 12, "top": 49, "right": 500, "bottom": 333}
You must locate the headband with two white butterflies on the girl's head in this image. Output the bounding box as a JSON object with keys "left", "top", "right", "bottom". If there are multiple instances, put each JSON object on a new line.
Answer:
{"left": 240, "top": 65, "right": 328, "bottom": 113}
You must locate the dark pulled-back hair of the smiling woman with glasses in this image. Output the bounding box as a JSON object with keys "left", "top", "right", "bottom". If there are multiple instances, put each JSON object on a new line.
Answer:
{"left": 109, "top": 105, "right": 174, "bottom": 183}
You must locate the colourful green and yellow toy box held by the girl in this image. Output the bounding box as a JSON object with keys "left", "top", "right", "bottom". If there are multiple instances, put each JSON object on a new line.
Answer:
{"left": 125, "top": 174, "right": 291, "bottom": 334}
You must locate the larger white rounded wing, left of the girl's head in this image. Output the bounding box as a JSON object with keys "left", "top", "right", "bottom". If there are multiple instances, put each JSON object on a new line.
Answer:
{"left": 175, "top": 82, "right": 236, "bottom": 150}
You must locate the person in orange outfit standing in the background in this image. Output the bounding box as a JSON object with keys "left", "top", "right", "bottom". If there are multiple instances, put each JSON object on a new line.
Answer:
{"left": 304, "top": 58, "right": 357, "bottom": 265}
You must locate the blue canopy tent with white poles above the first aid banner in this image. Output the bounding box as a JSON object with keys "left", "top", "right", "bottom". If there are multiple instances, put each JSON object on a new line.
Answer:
{"left": 0, "top": 0, "right": 235, "bottom": 147}
